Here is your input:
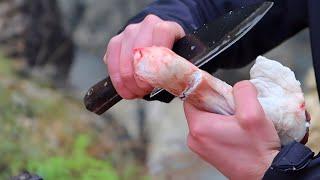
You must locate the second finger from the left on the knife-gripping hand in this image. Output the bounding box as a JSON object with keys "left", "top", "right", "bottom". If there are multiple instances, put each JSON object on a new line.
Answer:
{"left": 120, "top": 24, "right": 146, "bottom": 97}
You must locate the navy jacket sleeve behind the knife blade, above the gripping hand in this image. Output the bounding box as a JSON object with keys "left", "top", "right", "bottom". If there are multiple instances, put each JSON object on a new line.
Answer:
{"left": 124, "top": 0, "right": 308, "bottom": 72}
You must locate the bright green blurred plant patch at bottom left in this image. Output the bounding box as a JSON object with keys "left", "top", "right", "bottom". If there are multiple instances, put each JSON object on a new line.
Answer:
{"left": 28, "top": 135, "right": 119, "bottom": 180}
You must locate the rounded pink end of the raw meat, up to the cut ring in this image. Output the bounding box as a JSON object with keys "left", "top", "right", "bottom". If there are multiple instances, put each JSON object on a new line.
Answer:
{"left": 134, "top": 48, "right": 198, "bottom": 96}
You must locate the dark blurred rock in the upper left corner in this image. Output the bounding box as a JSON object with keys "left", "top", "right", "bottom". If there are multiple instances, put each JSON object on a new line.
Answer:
{"left": 0, "top": 0, "right": 73, "bottom": 86}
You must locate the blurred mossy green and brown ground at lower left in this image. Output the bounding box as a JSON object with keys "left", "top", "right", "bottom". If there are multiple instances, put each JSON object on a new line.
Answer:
{"left": 0, "top": 54, "right": 145, "bottom": 180}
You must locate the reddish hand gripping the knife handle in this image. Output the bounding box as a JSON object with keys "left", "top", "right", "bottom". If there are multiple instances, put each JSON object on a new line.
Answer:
{"left": 104, "top": 15, "right": 185, "bottom": 99}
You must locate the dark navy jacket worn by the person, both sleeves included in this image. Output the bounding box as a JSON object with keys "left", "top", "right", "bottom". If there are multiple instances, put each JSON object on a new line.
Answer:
{"left": 124, "top": 0, "right": 320, "bottom": 179}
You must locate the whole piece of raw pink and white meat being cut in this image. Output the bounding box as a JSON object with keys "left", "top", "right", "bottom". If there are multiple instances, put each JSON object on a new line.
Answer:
{"left": 134, "top": 47, "right": 309, "bottom": 145}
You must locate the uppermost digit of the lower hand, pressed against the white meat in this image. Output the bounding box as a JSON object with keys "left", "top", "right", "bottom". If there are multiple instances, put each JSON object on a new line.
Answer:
{"left": 233, "top": 81, "right": 266, "bottom": 126}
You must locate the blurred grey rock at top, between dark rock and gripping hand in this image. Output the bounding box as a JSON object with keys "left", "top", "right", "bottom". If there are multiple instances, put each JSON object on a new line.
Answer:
{"left": 58, "top": 0, "right": 152, "bottom": 55}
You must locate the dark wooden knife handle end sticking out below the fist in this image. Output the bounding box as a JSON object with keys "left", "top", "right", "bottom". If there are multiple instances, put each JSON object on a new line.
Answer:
{"left": 84, "top": 76, "right": 122, "bottom": 115}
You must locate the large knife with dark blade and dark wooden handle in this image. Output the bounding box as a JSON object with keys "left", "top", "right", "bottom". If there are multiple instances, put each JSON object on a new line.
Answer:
{"left": 84, "top": 2, "right": 273, "bottom": 115}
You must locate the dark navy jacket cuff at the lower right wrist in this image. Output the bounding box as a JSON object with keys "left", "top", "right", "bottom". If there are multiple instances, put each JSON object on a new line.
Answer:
{"left": 263, "top": 142, "right": 320, "bottom": 180}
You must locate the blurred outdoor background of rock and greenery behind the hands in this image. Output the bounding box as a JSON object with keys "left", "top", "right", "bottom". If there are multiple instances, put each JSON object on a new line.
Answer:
{"left": 0, "top": 0, "right": 320, "bottom": 180}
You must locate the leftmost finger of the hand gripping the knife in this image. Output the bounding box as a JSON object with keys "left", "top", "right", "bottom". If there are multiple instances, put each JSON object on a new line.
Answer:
{"left": 103, "top": 35, "right": 135, "bottom": 99}
